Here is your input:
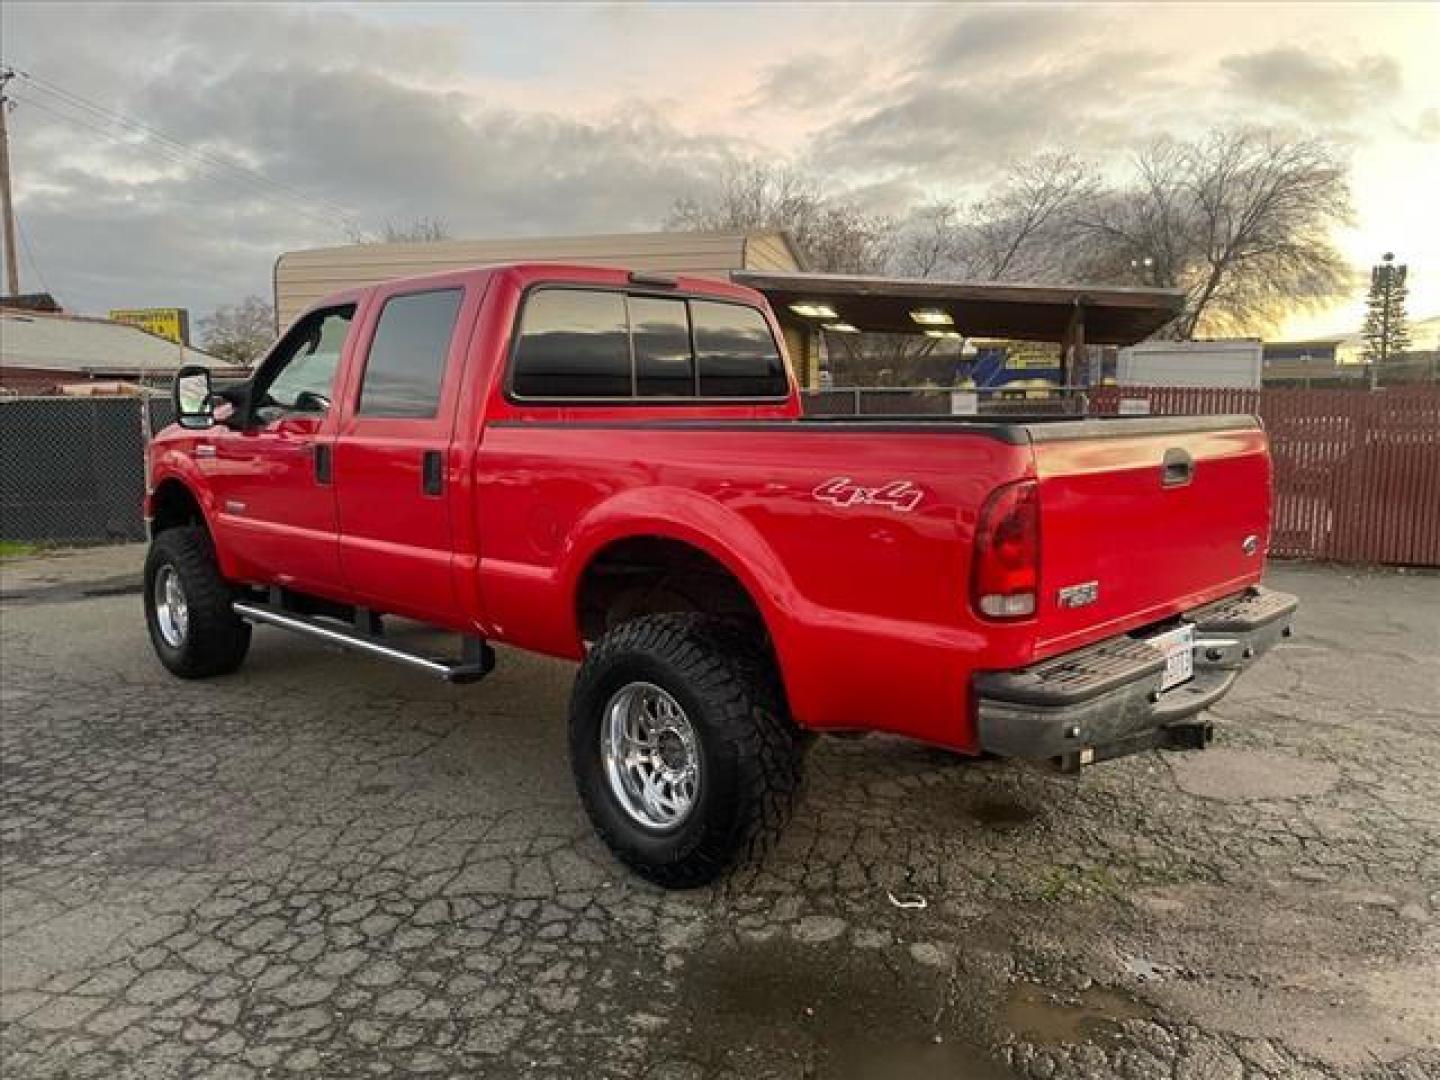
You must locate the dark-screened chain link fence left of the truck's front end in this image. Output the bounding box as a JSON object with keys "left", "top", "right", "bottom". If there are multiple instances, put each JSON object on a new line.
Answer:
{"left": 0, "top": 396, "right": 171, "bottom": 544}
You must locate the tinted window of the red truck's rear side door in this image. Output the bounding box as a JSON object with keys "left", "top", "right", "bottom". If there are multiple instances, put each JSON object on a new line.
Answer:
{"left": 359, "top": 289, "right": 462, "bottom": 418}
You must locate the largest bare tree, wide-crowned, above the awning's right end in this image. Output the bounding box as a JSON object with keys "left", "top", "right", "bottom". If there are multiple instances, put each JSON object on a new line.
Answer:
{"left": 1079, "top": 131, "right": 1351, "bottom": 338}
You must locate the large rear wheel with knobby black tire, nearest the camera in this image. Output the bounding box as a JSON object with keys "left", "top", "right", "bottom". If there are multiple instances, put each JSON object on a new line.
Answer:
{"left": 570, "top": 615, "right": 806, "bottom": 888}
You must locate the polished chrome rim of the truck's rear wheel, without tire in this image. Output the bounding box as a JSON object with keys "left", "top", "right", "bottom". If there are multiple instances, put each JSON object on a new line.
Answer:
{"left": 600, "top": 683, "right": 700, "bottom": 829}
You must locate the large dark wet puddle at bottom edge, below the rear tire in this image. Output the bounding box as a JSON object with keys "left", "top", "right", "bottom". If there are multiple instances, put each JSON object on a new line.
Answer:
{"left": 672, "top": 940, "right": 1015, "bottom": 1080}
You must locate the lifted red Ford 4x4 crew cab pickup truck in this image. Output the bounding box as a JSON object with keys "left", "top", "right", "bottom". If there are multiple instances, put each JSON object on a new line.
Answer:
{"left": 144, "top": 264, "right": 1296, "bottom": 887}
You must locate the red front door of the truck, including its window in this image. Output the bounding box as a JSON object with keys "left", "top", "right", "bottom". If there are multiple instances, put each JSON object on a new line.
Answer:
{"left": 206, "top": 304, "right": 356, "bottom": 593}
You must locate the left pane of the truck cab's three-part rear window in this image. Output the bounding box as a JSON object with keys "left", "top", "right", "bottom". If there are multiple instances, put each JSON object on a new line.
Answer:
{"left": 514, "top": 289, "right": 631, "bottom": 397}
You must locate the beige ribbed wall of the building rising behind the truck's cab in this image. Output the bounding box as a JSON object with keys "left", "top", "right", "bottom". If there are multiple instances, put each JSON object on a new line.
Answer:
{"left": 275, "top": 232, "right": 801, "bottom": 327}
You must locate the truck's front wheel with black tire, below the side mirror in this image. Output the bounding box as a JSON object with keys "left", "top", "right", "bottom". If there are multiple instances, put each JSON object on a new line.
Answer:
{"left": 145, "top": 526, "right": 251, "bottom": 678}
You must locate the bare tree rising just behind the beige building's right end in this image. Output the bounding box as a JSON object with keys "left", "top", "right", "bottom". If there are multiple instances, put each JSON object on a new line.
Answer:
{"left": 665, "top": 161, "right": 896, "bottom": 274}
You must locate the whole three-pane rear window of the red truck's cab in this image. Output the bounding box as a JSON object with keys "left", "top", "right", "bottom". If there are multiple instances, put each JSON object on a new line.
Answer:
{"left": 510, "top": 285, "right": 789, "bottom": 405}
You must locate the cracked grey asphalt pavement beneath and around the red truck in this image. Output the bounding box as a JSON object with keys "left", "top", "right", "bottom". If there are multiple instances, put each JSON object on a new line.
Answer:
{"left": 0, "top": 547, "right": 1440, "bottom": 1080}
